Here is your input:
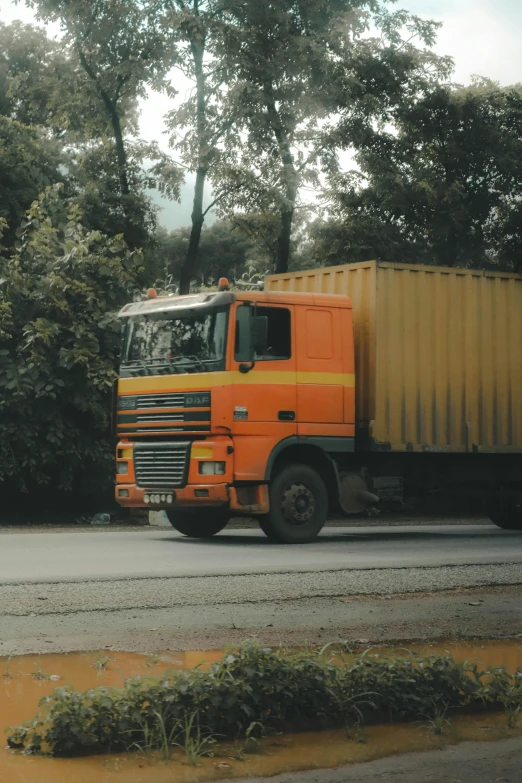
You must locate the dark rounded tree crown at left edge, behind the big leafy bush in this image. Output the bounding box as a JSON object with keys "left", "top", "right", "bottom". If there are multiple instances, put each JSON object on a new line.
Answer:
{"left": 0, "top": 116, "right": 67, "bottom": 248}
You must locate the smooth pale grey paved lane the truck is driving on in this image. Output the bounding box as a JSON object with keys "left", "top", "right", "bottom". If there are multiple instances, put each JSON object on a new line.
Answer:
{"left": 0, "top": 525, "right": 522, "bottom": 584}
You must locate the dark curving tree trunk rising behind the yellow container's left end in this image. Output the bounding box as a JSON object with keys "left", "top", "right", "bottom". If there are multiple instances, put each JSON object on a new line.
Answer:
{"left": 266, "top": 94, "right": 299, "bottom": 274}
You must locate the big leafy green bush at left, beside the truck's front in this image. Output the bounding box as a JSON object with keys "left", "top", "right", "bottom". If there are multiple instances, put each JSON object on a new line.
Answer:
{"left": 0, "top": 185, "right": 141, "bottom": 494}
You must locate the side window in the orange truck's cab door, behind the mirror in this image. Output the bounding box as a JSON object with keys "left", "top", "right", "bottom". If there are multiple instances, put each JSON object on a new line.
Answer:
{"left": 235, "top": 307, "right": 292, "bottom": 362}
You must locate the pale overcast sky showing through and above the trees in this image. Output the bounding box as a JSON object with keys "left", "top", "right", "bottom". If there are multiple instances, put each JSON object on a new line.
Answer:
{"left": 0, "top": 0, "right": 522, "bottom": 228}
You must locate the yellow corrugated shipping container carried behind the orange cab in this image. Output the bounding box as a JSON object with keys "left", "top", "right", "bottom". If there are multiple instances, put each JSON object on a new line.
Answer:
{"left": 266, "top": 261, "right": 522, "bottom": 453}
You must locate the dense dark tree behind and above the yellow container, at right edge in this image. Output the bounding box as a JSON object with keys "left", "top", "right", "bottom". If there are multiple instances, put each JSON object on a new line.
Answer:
{"left": 314, "top": 79, "right": 522, "bottom": 269}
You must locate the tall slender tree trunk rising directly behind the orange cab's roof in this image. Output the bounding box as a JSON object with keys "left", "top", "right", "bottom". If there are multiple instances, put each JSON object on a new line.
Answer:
{"left": 179, "top": 35, "right": 208, "bottom": 294}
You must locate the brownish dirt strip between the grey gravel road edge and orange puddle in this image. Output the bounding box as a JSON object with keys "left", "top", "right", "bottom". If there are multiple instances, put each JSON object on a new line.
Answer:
{"left": 0, "top": 585, "right": 522, "bottom": 655}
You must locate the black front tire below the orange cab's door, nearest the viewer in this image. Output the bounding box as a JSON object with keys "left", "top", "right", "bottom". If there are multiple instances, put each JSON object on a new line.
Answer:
{"left": 259, "top": 464, "right": 328, "bottom": 544}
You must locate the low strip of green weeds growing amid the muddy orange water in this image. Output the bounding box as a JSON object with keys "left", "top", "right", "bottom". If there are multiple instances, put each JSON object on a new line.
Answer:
{"left": 8, "top": 644, "right": 522, "bottom": 756}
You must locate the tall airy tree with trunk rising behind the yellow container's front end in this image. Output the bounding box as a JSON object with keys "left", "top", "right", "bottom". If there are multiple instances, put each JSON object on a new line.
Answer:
{"left": 211, "top": 0, "right": 450, "bottom": 272}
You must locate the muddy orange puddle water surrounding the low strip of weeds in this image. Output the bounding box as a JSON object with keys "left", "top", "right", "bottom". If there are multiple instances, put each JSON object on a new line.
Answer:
{"left": 0, "top": 640, "right": 522, "bottom": 783}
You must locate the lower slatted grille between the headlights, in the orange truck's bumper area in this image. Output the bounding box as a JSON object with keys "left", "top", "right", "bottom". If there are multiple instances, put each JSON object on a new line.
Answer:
{"left": 134, "top": 442, "right": 190, "bottom": 489}
